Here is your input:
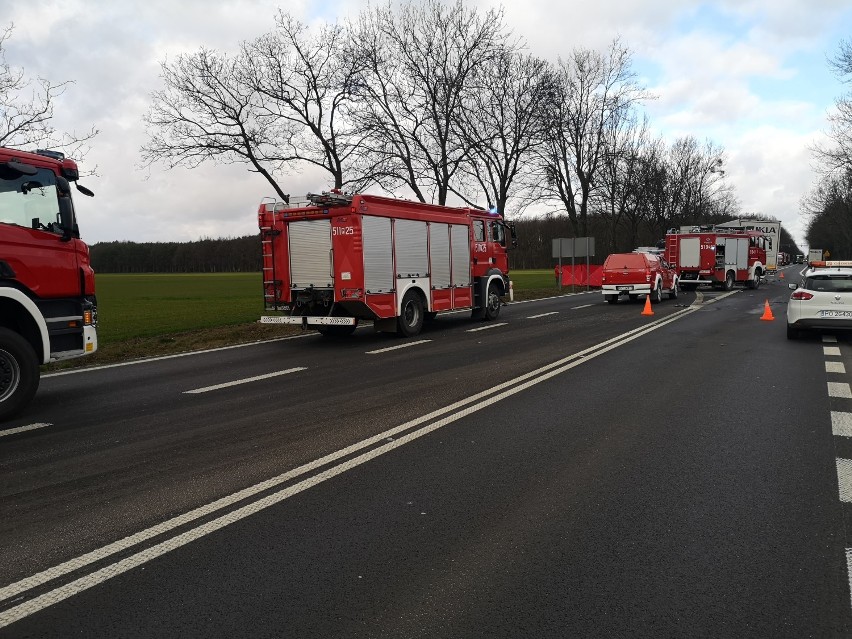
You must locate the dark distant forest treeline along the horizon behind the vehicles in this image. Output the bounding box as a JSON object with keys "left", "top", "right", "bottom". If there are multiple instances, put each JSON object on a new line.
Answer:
{"left": 91, "top": 216, "right": 798, "bottom": 273}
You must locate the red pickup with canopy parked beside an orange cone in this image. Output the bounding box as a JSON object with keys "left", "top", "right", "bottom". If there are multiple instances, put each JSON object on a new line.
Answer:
{"left": 601, "top": 252, "right": 678, "bottom": 304}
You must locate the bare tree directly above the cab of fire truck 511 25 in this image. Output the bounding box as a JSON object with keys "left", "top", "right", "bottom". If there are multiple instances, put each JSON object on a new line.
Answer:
{"left": 450, "top": 46, "right": 554, "bottom": 212}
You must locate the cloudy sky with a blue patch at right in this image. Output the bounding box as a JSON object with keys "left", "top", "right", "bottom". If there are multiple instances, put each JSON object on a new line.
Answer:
{"left": 0, "top": 0, "right": 852, "bottom": 248}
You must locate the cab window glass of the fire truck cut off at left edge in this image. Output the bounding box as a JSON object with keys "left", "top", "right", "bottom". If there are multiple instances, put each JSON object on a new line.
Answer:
{"left": 0, "top": 169, "right": 60, "bottom": 232}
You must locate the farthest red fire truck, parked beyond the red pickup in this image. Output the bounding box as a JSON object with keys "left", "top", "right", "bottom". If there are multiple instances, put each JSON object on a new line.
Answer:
{"left": 665, "top": 226, "right": 772, "bottom": 291}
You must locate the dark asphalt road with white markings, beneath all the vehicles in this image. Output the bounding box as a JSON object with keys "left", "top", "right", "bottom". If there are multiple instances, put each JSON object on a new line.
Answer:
{"left": 0, "top": 271, "right": 852, "bottom": 637}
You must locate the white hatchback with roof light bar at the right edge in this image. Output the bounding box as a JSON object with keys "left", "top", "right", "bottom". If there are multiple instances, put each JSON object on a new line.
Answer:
{"left": 787, "top": 260, "right": 852, "bottom": 339}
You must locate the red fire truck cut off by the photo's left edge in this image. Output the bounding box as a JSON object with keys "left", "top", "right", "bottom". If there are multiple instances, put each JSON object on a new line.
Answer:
{"left": 0, "top": 148, "right": 98, "bottom": 420}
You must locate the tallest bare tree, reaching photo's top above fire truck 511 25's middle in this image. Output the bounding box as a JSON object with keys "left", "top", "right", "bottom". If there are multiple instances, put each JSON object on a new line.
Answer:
{"left": 353, "top": 0, "right": 505, "bottom": 204}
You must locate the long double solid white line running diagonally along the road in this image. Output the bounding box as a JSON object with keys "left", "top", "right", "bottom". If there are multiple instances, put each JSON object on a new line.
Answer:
{"left": 0, "top": 308, "right": 697, "bottom": 628}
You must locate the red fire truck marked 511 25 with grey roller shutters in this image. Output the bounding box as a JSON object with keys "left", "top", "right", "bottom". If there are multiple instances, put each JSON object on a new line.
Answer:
{"left": 258, "top": 191, "right": 516, "bottom": 337}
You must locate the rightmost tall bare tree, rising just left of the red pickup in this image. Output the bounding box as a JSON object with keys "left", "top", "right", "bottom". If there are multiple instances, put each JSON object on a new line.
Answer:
{"left": 539, "top": 39, "right": 647, "bottom": 236}
